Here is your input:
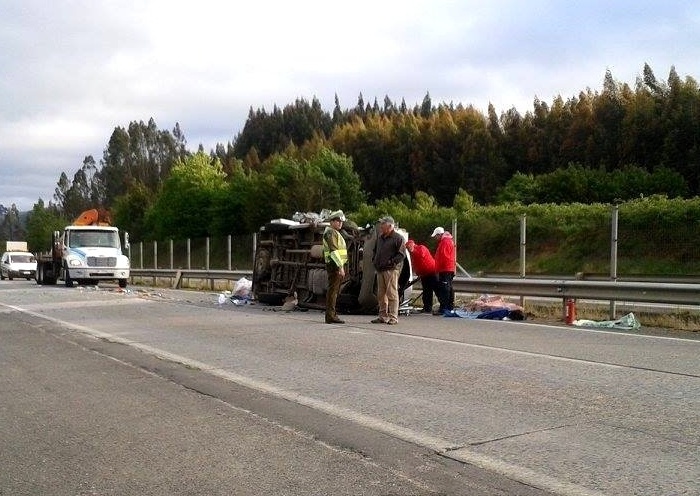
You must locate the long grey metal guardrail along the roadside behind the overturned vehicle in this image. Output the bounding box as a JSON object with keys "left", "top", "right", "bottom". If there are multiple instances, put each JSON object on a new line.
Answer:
{"left": 131, "top": 269, "right": 700, "bottom": 305}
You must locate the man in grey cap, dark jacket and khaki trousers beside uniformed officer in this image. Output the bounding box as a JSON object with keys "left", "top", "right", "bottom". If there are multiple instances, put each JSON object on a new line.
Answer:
{"left": 372, "top": 216, "right": 406, "bottom": 325}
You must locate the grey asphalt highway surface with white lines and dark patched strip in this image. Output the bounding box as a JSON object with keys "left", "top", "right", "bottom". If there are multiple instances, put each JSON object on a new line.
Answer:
{"left": 0, "top": 281, "right": 700, "bottom": 496}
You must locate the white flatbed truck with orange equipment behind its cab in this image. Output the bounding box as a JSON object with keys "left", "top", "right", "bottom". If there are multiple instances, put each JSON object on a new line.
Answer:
{"left": 35, "top": 209, "right": 130, "bottom": 288}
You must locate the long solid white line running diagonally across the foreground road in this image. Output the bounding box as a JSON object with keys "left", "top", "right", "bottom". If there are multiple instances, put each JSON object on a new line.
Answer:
{"left": 0, "top": 303, "right": 605, "bottom": 496}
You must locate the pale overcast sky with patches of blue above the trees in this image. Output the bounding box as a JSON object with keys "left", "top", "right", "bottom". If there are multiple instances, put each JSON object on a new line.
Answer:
{"left": 0, "top": 0, "right": 700, "bottom": 210}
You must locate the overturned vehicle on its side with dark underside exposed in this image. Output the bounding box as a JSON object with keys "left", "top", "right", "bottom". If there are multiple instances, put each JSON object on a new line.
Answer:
{"left": 253, "top": 216, "right": 411, "bottom": 314}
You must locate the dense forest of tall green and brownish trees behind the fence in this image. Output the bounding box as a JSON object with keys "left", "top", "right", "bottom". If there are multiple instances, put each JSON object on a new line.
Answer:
{"left": 0, "top": 65, "right": 700, "bottom": 250}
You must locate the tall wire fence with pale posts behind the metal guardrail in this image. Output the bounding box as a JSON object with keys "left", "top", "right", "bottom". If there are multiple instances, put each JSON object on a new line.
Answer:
{"left": 129, "top": 208, "right": 700, "bottom": 278}
